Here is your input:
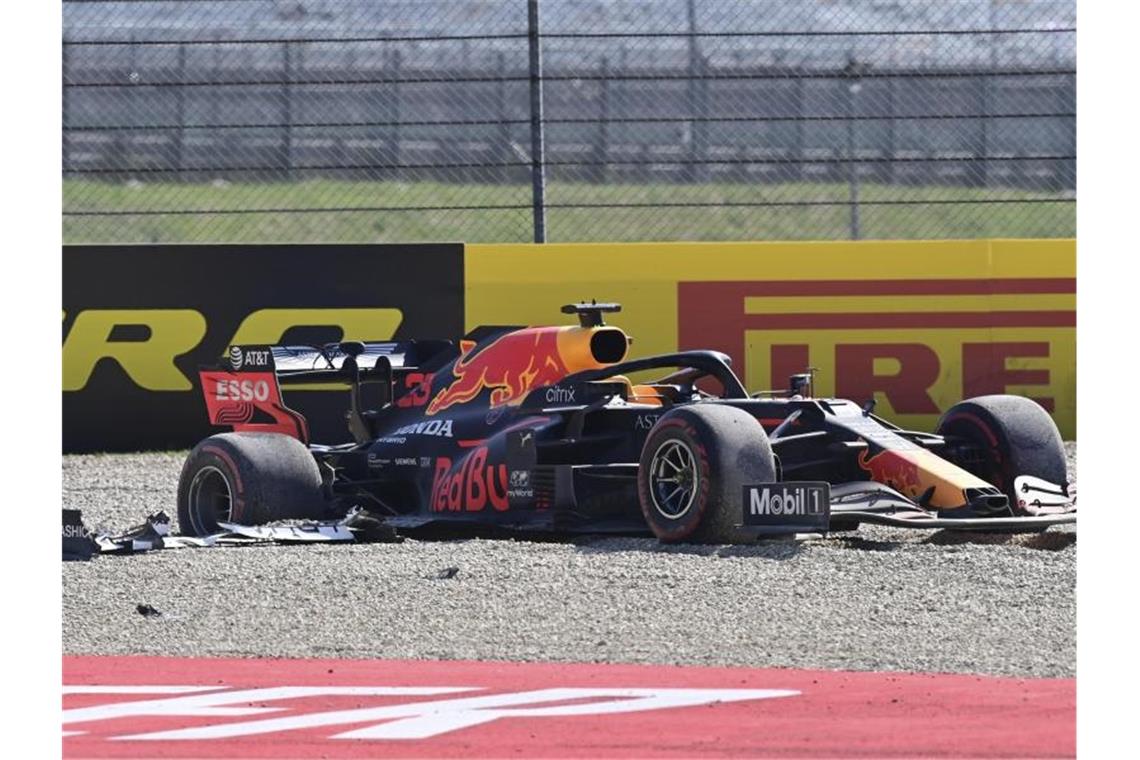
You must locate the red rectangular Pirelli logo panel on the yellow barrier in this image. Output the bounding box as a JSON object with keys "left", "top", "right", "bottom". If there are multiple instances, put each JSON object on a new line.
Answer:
{"left": 677, "top": 278, "right": 1076, "bottom": 425}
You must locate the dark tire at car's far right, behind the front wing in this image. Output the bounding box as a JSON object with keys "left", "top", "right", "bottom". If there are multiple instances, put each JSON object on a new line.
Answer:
{"left": 936, "top": 395, "right": 1068, "bottom": 514}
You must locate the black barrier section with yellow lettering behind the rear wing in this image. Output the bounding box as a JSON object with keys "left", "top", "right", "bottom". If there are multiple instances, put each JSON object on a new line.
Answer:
{"left": 63, "top": 243, "right": 464, "bottom": 452}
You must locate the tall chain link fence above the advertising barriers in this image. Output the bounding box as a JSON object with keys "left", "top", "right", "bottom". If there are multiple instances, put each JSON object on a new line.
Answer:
{"left": 63, "top": 0, "right": 1076, "bottom": 243}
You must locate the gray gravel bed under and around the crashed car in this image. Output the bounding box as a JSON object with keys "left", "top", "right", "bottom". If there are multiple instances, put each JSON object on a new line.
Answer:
{"left": 63, "top": 444, "right": 1076, "bottom": 677}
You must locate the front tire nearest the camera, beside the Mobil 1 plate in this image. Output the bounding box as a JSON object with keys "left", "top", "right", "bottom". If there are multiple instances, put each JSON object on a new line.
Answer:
{"left": 637, "top": 403, "right": 776, "bottom": 544}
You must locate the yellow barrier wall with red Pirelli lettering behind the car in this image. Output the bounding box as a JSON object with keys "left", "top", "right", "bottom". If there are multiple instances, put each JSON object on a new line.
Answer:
{"left": 465, "top": 239, "right": 1076, "bottom": 439}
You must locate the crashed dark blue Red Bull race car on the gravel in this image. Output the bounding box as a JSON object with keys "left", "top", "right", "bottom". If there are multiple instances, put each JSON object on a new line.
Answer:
{"left": 178, "top": 303, "right": 1076, "bottom": 544}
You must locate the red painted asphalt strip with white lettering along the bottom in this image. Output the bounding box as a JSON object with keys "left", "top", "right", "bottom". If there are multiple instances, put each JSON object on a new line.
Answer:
{"left": 64, "top": 656, "right": 1076, "bottom": 759}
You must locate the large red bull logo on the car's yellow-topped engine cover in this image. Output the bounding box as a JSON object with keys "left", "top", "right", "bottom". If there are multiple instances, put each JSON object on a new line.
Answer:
{"left": 425, "top": 327, "right": 569, "bottom": 415}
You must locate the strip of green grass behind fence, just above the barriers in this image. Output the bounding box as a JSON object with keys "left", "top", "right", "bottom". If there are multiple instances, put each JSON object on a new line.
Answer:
{"left": 64, "top": 179, "right": 1076, "bottom": 244}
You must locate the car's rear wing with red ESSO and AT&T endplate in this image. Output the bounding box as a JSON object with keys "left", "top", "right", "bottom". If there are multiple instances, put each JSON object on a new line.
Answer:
{"left": 198, "top": 341, "right": 454, "bottom": 443}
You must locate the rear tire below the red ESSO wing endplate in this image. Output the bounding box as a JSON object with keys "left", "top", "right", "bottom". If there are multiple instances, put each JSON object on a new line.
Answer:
{"left": 178, "top": 433, "right": 325, "bottom": 536}
